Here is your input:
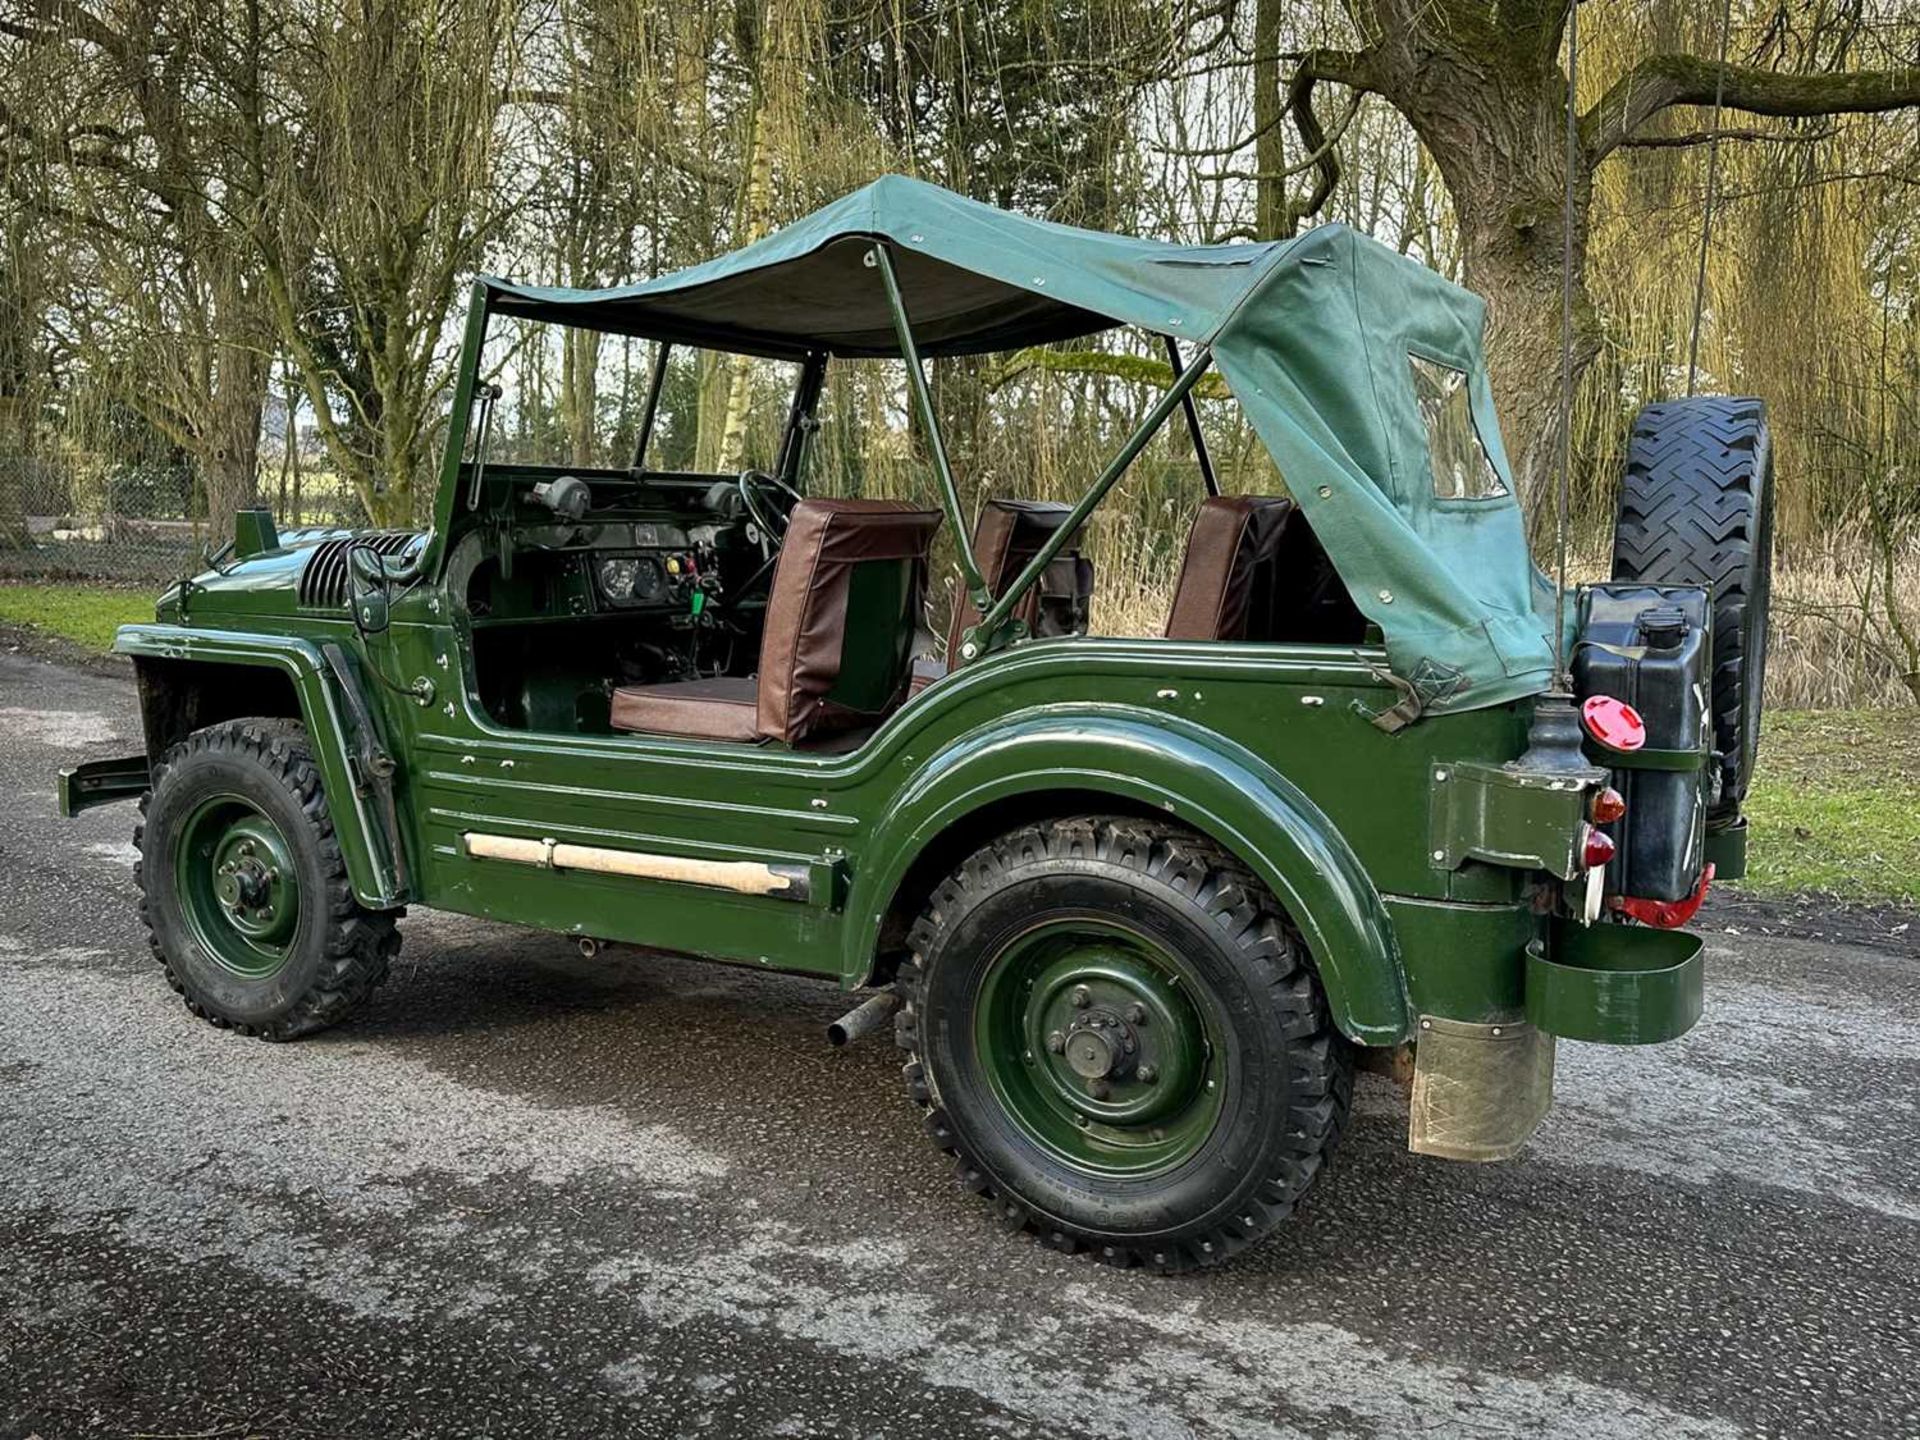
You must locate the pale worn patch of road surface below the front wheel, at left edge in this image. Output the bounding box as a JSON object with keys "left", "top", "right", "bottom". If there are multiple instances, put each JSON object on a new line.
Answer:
{"left": 0, "top": 963, "right": 726, "bottom": 1319}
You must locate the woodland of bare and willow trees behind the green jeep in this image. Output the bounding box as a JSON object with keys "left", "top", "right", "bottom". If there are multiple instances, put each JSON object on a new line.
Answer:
{"left": 0, "top": 0, "right": 1920, "bottom": 705}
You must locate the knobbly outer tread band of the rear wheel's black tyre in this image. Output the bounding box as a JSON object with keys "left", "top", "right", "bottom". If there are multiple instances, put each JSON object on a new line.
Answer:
{"left": 893, "top": 816, "right": 1354, "bottom": 1273}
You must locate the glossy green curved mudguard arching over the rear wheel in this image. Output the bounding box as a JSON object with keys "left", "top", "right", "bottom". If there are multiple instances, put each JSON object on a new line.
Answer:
{"left": 843, "top": 712, "right": 1411, "bottom": 1044}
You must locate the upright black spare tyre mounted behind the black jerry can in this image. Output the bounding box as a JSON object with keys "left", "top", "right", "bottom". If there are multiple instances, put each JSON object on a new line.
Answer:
{"left": 1613, "top": 396, "right": 1774, "bottom": 829}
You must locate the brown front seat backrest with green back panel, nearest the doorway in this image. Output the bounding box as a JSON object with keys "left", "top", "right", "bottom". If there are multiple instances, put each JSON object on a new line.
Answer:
{"left": 755, "top": 499, "right": 941, "bottom": 745}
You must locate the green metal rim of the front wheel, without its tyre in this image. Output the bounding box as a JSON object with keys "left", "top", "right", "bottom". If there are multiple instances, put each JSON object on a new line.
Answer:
{"left": 173, "top": 795, "right": 300, "bottom": 979}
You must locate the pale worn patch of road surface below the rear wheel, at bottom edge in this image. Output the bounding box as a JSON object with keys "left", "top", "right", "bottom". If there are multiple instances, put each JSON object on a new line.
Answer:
{"left": 589, "top": 1227, "right": 1740, "bottom": 1440}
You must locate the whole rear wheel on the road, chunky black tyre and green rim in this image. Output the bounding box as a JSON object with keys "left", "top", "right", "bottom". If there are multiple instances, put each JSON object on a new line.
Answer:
{"left": 897, "top": 818, "right": 1352, "bottom": 1271}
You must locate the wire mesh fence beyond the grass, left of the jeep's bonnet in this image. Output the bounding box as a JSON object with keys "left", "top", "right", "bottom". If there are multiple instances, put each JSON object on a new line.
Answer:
{"left": 0, "top": 455, "right": 365, "bottom": 582}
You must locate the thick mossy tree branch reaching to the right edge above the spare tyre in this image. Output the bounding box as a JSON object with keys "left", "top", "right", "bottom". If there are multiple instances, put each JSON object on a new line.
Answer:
{"left": 1580, "top": 56, "right": 1920, "bottom": 165}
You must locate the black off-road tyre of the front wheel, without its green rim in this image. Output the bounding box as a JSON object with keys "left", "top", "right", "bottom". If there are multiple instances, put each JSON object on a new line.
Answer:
{"left": 132, "top": 718, "right": 405, "bottom": 1041}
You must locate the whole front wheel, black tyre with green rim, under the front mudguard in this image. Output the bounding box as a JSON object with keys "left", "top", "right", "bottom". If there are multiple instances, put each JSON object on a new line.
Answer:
{"left": 134, "top": 720, "right": 399, "bottom": 1041}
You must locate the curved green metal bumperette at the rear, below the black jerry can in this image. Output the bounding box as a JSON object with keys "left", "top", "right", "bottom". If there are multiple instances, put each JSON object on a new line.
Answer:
{"left": 1526, "top": 924, "right": 1705, "bottom": 1044}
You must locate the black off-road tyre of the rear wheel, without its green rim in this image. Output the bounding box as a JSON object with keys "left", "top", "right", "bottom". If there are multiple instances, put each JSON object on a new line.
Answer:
{"left": 895, "top": 816, "right": 1354, "bottom": 1271}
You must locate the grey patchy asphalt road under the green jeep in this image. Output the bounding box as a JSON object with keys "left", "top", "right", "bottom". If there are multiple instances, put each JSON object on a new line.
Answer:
{"left": 0, "top": 655, "right": 1920, "bottom": 1440}
